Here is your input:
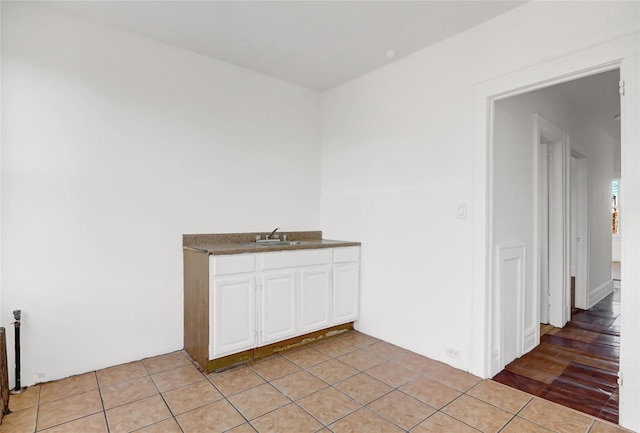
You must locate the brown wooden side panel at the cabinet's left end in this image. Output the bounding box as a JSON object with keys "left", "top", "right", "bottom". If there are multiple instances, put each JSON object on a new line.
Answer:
{"left": 183, "top": 250, "right": 209, "bottom": 369}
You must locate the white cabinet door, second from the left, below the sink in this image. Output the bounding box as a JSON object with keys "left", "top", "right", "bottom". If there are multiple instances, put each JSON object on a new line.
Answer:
{"left": 259, "top": 271, "right": 296, "bottom": 346}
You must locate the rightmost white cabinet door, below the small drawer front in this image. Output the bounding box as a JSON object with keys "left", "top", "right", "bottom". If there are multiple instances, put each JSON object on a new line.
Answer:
{"left": 333, "top": 263, "right": 360, "bottom": 325}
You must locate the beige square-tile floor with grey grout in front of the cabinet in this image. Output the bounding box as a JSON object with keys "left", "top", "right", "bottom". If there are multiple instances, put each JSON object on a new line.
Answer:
{"left": 0, "top": 331, "right": 626, "bottom": 433}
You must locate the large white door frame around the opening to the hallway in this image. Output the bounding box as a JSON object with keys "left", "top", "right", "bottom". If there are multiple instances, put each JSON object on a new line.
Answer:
{"left": 470, "top": 36, "right": 640, "bottom": 429}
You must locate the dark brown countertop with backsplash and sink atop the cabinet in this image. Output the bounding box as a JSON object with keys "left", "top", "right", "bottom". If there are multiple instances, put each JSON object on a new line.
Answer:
{"left": 182, "top": 231, "right": 360, "bottom": 255}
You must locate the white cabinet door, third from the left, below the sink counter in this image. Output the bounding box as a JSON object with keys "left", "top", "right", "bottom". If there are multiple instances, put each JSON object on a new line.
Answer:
{"left": 298, "top": 268, "right": 331, "bottom": 334}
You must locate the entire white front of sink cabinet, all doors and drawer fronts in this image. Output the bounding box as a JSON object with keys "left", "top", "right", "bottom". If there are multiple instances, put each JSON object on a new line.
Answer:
{"left": 209, "top": 247, "right": 360, "bottom": 359}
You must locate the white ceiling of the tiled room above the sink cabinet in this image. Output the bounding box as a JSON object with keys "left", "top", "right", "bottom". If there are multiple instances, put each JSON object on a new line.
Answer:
{"left": 42, "top": 0, "right": 525, "bottom": 90}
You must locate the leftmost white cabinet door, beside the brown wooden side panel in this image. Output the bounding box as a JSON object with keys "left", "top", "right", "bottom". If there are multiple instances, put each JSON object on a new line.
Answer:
{"left": 209, "top": 274, "right": 256, "bottom": 359}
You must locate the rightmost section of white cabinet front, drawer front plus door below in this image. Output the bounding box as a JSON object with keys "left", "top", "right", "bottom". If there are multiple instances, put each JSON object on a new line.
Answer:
{"left": 332, "top": 247, "right": 360, "bottom": 325}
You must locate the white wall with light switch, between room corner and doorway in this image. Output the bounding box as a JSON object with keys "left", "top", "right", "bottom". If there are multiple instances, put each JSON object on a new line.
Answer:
{"left": 322, "top": 2, "right": 638, "bottom": 376}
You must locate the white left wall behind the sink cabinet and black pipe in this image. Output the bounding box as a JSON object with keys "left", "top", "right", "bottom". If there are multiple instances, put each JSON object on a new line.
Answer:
{"left": 0, "top": 2, "right": 320, "bottom": 385}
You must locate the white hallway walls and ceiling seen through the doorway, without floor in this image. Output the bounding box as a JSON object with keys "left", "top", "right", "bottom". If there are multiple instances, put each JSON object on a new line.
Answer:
{"left": 491, "top": 68, "right": 620, "bottom": 373}
